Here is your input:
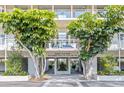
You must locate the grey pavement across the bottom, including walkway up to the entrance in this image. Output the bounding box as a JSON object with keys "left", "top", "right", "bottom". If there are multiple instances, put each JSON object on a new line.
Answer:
{"left": 0, "top": 75, "right": 124, "bottom": 87}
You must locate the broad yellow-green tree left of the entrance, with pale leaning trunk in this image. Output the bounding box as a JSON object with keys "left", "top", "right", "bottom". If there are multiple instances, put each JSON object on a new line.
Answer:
{"left": 0, "top": 9, "right": 56, "bottom": 77}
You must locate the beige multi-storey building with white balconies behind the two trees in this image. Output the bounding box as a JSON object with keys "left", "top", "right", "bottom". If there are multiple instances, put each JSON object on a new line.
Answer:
{"left": 0, "top": 5, "right": 124, "bottom": 78}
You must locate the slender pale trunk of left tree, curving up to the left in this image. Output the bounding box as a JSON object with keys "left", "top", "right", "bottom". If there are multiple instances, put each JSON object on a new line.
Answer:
{"left": 16, "top": 39, "right": 40, "bottom": 78}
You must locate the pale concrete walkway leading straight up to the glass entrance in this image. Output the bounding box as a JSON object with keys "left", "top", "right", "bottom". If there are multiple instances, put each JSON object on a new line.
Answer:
{"left": 43, "top": 75, "right": 82, "bottom": 87}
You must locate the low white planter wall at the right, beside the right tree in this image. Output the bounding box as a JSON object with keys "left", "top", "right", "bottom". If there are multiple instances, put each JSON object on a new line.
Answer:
{"left": 97, "top": 75, "right": 124, "bottom": 81}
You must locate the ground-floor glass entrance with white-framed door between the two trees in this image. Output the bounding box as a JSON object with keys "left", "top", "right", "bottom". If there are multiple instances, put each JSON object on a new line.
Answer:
{"left": 46, "top": 58, "right": 83, "bottom": 75}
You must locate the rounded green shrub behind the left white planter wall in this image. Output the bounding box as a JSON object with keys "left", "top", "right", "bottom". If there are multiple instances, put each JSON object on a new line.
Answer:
{"left": 3, "top": 52, "right": 27, "bottom": 76}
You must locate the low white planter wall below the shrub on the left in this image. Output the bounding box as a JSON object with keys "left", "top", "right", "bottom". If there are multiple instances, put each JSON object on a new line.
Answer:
{"left": 0, "top": 76, "right": 29, "bottom": 82}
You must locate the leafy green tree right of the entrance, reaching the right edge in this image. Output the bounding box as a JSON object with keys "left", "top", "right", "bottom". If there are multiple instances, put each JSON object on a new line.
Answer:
{"left": 67, "top": 6, "right": 124, "bottom": 78}
